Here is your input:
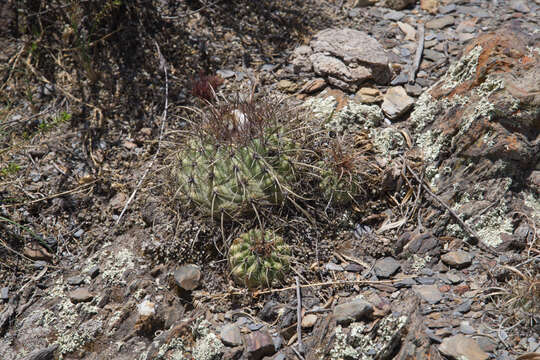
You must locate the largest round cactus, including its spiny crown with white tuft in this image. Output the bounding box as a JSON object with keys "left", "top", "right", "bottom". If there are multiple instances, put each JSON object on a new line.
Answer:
{"left": 173, "top": 100, "right": 294, "bottom": 221}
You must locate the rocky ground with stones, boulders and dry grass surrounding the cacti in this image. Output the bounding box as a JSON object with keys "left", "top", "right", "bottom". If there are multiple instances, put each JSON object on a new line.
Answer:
{"left": 0, "top": 0, "right": 540, "bottom": 360}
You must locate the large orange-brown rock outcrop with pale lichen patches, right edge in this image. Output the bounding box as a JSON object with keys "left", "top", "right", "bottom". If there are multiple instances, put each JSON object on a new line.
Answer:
{"left": 410, "top": 29, "right": 540, "bottom": 246}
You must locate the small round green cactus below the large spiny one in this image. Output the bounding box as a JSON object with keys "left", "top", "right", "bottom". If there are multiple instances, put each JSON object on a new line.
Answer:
{"left": 229, "top": 229, "right": 290, "bottom": 288}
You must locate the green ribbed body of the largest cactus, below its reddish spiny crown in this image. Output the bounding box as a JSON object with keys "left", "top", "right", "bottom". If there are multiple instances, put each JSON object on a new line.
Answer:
{"left": 175, "top": 129, "right": 294, "bottom": 220}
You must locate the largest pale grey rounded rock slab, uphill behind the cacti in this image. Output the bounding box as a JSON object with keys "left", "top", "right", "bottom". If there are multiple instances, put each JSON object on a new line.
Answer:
{"left": 310, "top": 28, "right": 392, "bottom": 84}
